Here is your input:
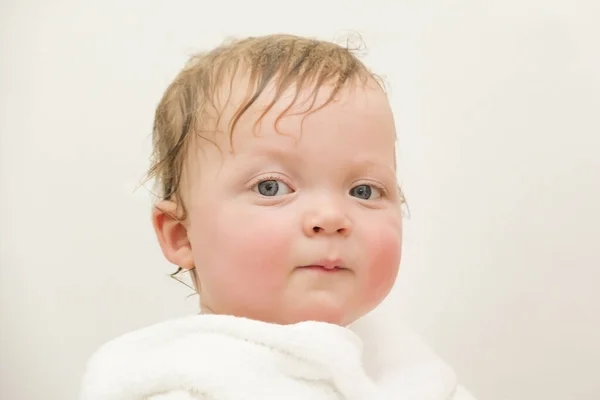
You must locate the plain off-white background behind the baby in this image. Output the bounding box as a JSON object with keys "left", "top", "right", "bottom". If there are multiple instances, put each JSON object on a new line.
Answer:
{"left": 0, "top": 0, "right": 600, "bottom": 400}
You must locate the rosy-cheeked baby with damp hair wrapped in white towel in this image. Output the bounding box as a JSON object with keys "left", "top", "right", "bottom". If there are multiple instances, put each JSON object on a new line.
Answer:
{"left": 82, "top": 35, "right": 471, "bottom": 400}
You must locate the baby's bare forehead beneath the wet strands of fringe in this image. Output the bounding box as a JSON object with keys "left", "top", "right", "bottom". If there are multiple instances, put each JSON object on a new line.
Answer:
{"left": 204, "top": 77, "right": 395, "bottom": 153}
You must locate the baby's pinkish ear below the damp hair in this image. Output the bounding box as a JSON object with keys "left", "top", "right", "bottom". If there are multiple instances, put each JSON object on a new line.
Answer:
{"left": 152, "top": 200, "right": 194, "bottom": 270}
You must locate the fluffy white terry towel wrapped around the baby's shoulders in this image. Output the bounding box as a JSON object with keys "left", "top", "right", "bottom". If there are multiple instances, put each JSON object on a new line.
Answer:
{"left": 81, "top": 315, "right": 470, "bottom": 400}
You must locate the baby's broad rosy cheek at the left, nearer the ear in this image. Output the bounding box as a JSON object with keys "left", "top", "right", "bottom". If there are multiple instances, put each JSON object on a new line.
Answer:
{"left": 192, "top": 204, "right": 294, "bottom": 294}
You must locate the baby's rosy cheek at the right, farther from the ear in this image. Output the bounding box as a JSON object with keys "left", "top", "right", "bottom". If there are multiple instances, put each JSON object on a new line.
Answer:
{"left": 364, "top": 217, "right": 402, "bottom": 305}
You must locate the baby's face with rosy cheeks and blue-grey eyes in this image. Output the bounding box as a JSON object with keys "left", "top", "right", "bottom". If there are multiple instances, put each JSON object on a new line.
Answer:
{"left": 180, "top": 80, "right": 402, "bottom": 325}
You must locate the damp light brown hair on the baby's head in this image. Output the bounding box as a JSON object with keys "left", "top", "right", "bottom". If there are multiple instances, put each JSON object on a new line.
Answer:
{"left": 148, "top": 35, "right": 383, "bottom": 218}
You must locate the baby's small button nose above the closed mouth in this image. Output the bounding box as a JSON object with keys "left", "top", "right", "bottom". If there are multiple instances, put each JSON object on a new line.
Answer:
{"left": 303, "top": 205, "right": 352, "bottom": 237}
